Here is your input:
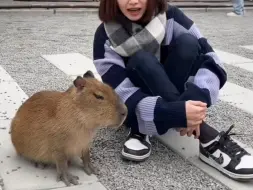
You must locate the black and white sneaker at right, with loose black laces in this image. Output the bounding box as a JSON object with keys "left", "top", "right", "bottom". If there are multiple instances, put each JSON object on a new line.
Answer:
{"left": 199, "top": 125, "right": 253, "bottom": 181}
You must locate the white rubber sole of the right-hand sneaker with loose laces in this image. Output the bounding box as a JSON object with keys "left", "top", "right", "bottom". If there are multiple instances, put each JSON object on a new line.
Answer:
{"left": 199, "top": 153, "right": 253, "bottom": 181}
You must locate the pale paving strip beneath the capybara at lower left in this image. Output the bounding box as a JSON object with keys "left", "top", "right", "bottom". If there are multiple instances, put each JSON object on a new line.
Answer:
{"left": 0, "top": 66, "right": 104, "bottom": 190}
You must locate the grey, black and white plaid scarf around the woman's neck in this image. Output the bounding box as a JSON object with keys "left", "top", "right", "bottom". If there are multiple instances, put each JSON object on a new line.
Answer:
{"left": 105, "top": 13, "right": 166, "bottom": 59}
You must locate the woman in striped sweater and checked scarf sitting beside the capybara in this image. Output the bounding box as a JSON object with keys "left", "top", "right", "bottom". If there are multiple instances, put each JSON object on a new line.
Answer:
{"left": 93, "top": 0, "right": 253, "bottom": 179}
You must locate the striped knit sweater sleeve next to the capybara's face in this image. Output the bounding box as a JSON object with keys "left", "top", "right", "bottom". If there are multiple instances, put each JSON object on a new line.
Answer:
{"left": 93, "top": 24, "right": 187, "bottom": 135}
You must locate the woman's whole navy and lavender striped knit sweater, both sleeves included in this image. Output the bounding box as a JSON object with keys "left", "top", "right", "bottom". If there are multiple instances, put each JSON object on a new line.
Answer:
{"left": 93, "top": 6, "right": 227, "bottom": 135}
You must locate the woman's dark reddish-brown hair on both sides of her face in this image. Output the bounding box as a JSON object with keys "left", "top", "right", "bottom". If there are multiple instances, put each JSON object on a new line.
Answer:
{"left": 98, "top": 0, "right": 168, "bottom": 22}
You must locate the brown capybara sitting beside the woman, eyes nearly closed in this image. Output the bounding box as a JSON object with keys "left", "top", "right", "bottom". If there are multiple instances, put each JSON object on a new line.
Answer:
{"left": 11, "top": 71, "right": 127, "bottom": 186}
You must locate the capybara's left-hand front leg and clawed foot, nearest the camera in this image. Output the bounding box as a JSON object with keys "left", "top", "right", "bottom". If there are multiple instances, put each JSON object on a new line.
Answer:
{"left": 56, "top": 155, "right": 79, "bottom": 186}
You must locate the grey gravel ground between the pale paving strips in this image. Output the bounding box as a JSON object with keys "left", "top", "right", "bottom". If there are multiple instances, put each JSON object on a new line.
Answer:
{"left": 0, "top": 7, "right": 253, "bottom": 190}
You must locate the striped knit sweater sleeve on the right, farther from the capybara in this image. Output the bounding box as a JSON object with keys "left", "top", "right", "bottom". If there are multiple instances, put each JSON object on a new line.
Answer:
{"left": 172, "top": 7, "right": 227, "bottom": 107}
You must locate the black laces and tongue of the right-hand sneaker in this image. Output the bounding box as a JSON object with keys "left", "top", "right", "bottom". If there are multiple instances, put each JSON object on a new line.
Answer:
{"left": 219, "top": 124, "right": 248, "bottom": 157}
